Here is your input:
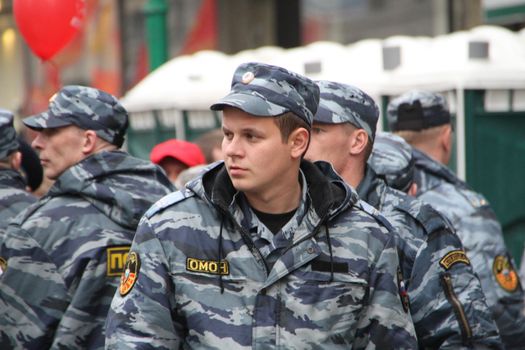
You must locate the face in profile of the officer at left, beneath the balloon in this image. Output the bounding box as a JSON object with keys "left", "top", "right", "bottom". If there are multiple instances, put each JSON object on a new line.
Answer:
{"left": 32, "top": 125, "right": 85, "bottom": 180}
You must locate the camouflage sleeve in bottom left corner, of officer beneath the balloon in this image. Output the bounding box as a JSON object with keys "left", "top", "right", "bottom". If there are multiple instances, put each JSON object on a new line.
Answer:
{"left": 0, "top": 225, "right": 70, "bottom": 349}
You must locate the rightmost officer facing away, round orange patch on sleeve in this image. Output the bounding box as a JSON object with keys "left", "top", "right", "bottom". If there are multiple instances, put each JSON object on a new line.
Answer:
{"left": 387, "top": 90, "right": 525, "bottom": 349}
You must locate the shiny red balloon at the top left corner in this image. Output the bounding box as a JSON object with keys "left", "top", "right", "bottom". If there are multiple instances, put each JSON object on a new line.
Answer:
{"left": 13, "top": 0, "right": 85, "bottom": 60}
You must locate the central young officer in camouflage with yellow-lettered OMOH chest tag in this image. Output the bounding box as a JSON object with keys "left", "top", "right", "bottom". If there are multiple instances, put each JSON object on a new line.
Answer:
{"left": 106, "top": 63, "right": 416, "bottom": 349}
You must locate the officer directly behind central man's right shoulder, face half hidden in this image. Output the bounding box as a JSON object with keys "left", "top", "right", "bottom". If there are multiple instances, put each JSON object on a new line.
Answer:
{"left": 306, "top": 81, "right": 501, "bottom": 349}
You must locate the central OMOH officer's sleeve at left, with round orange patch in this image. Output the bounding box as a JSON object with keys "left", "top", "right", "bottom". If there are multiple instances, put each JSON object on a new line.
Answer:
{"left": 106, "top": 217, "right": 184, "bottom": 349}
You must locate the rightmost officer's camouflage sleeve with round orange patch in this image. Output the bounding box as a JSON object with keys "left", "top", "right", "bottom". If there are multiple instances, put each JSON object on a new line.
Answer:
{"left": 457, "top": 206, "right": 525, "bottom": 349}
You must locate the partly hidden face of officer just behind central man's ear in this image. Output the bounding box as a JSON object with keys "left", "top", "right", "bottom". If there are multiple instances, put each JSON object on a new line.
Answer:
{"left": 305, "top": 122, "right": 351, "bottom": 173}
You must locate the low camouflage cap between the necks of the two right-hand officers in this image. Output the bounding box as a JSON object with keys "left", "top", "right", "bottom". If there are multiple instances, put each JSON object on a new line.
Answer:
{"left": 368, "top": 132, "right": 415, "bottom": 193}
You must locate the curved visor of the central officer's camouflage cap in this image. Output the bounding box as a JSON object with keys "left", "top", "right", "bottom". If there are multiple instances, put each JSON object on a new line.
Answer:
{"left": 210, "top": 93, "right": 289, "bottom": 117}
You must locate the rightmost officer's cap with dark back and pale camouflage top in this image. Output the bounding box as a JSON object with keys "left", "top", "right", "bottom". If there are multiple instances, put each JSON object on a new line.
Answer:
{"left": 387, "top": 90, "right": 450, "bottom": 131}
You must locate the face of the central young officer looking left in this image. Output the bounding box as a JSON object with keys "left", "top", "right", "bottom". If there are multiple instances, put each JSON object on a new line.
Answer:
{"left": 222, "top": 107, "right": 297, "bottom": 197}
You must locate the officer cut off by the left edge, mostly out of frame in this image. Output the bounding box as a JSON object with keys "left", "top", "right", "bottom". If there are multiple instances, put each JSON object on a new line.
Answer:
{"left": 0, "top": 109, "right": 36, "bottom": 230}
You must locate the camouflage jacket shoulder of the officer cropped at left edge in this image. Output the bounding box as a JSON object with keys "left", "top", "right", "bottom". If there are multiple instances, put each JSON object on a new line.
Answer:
{"left": 0, "top": 169, "right": 36, "bottom": 228}
